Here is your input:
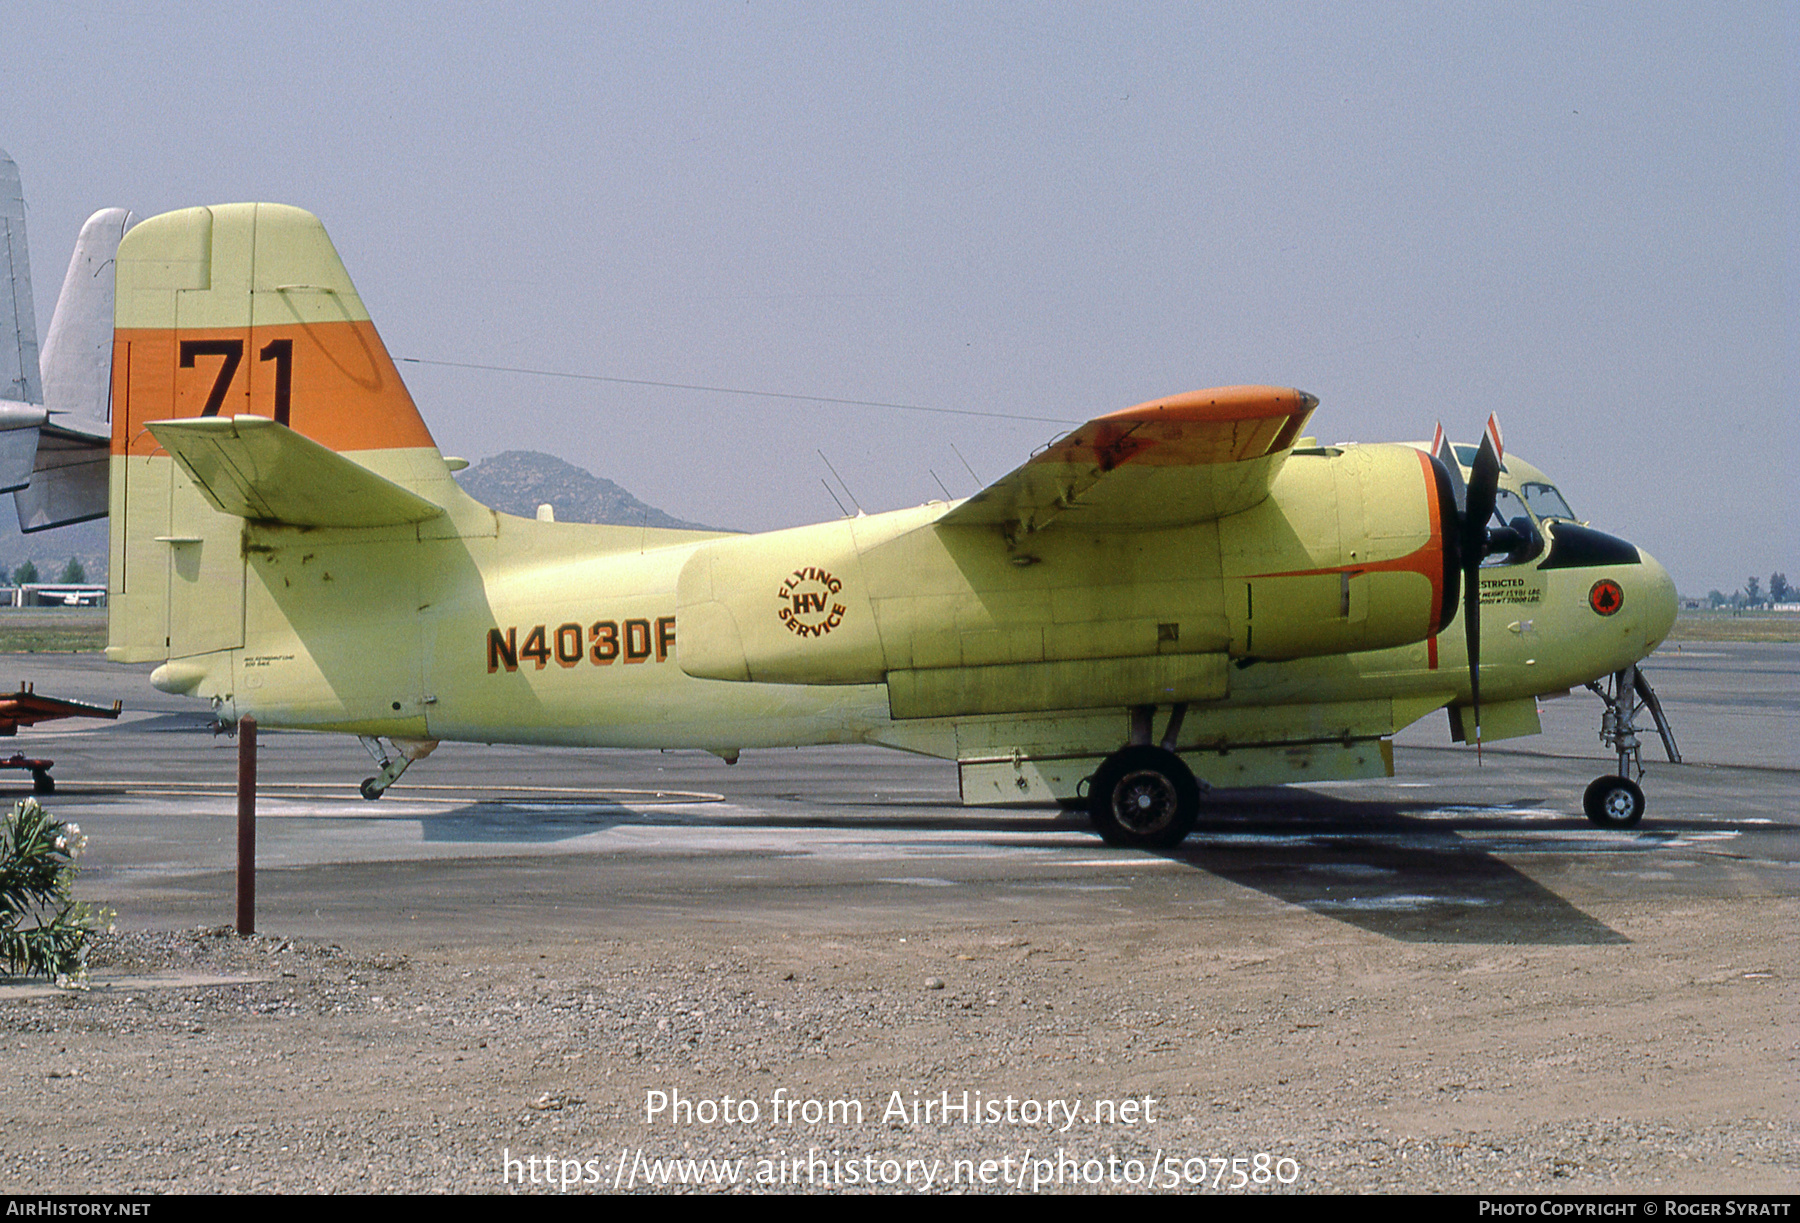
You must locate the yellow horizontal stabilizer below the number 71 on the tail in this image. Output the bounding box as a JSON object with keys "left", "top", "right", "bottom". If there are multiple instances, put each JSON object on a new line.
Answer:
{"left": 149, "top": 416, "right": 443, "bottom": 526}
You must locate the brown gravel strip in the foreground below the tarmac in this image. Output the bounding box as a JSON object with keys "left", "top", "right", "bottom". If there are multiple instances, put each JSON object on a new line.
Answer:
{"left": 0, "top": 913, "right": 1800, "bottom": 1192}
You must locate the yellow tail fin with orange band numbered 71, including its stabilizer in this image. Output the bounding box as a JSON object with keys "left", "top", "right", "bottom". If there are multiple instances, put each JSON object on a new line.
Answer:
{"left": 106, "top": 204, "right": 464, "bottom": 661}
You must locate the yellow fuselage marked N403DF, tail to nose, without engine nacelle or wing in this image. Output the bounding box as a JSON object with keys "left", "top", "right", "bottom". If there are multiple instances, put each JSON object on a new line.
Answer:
{"left": 158, "top": 439, "right": 1674, "bottom": 778}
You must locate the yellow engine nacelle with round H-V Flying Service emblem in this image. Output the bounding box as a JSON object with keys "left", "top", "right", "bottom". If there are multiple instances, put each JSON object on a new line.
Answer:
{"left": 677, "top": 447, "right": 1456, "bottom": 717}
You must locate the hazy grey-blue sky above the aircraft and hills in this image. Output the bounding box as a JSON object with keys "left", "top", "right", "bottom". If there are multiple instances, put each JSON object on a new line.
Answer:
{"left": 0, "top": 0, "right": 1800, "bottom": 593}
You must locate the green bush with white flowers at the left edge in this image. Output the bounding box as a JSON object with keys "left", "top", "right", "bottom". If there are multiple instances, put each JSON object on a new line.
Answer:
{"left": 0, "top": 798, "right": 112, "bottom": 985}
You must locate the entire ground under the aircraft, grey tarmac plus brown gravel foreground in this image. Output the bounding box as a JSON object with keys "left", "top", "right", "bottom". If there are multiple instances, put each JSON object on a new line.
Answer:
{"left": 0, "top": 645, "right": 1800, "bottom": 1192}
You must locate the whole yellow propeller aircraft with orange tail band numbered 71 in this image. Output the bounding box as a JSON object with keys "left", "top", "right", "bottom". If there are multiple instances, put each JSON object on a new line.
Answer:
{"left": 106, "top": 204, "right": 1674, "bottom": 847}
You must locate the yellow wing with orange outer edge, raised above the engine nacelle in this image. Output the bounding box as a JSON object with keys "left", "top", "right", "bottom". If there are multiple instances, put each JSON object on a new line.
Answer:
{"left": 940, "top": 387, "right": 1319, "bottom": 539}
